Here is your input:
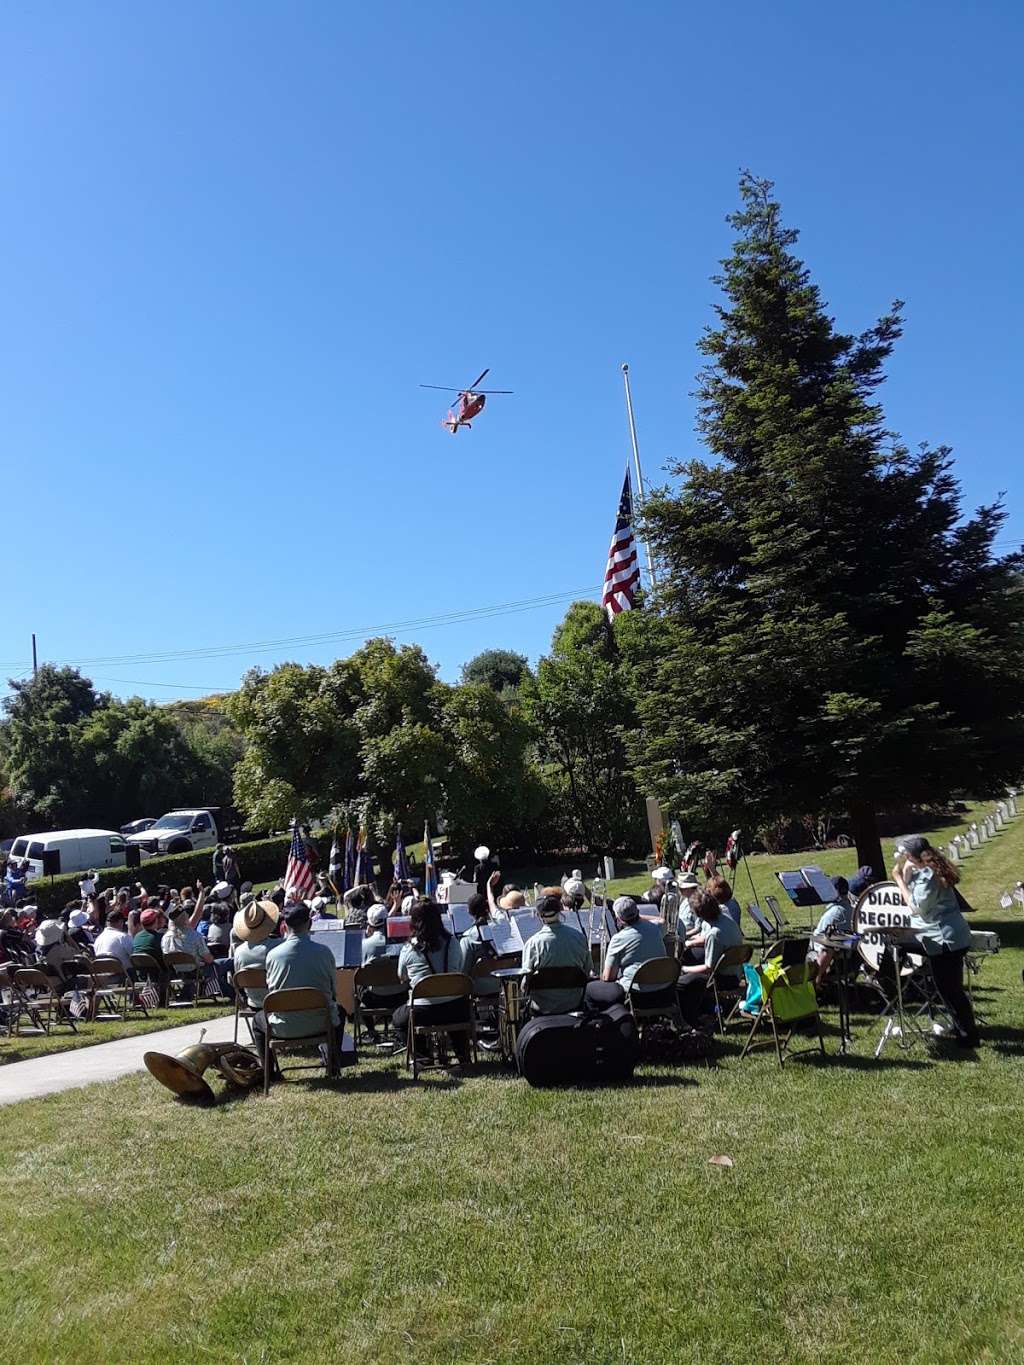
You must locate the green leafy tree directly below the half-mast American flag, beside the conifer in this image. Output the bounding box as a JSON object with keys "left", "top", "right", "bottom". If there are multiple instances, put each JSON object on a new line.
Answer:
{"left": 523, "top": 602, "right": 643, "bottom": 849}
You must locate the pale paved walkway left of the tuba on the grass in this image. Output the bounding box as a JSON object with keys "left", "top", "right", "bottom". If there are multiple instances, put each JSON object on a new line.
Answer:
{"left": 0, "top": 1010, "right": 236, "bottom": 1104}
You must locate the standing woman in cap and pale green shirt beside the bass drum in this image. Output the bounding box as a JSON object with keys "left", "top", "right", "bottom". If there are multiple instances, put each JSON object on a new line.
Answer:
{"left": 893, "top": 834, "right": 980, "bottom": 1047}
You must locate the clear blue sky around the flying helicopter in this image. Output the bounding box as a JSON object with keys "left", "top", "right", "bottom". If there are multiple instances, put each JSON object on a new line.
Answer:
{"left": 0, "top": 0, "right": 1024, "bottom": 700}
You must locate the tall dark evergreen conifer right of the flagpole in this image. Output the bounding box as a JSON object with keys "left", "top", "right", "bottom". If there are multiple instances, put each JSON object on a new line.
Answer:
{"left": 632, "top": 175, "right": 1024, "bottom": 872}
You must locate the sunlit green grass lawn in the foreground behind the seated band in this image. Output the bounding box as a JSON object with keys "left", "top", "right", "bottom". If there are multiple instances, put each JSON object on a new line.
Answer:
{"left": 0, "top": 797, "right": 1024, "bottom": 1365}
